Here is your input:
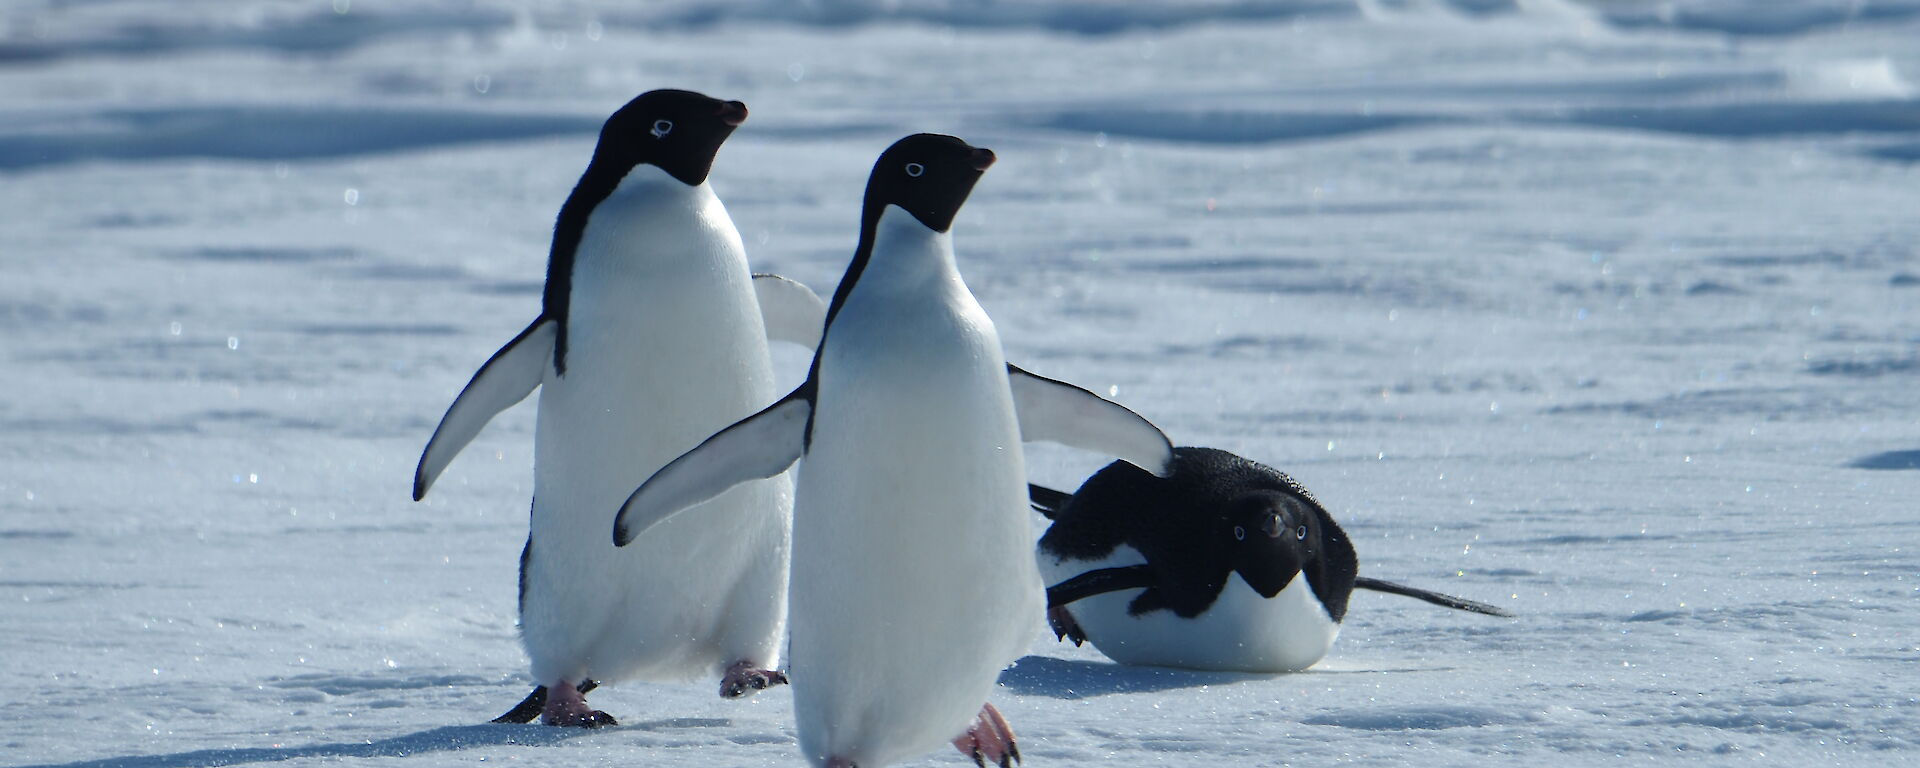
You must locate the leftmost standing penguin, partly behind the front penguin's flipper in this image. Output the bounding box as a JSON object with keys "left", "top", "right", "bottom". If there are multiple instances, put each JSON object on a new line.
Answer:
{"left": 413, "top": 90, "right": 826, "bottom": 726}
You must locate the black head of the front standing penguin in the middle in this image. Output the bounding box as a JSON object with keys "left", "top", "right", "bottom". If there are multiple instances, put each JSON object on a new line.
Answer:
{"left": 862, "top": 132, "right": 993, "bottom": 232}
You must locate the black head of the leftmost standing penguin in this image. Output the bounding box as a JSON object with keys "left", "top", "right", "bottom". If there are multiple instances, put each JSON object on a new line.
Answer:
{"left": 589, "top": 90, "right": 747, "bottom": 186}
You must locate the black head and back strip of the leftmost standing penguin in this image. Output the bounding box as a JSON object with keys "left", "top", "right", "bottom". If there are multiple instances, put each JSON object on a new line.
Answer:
{"left": 541, "top": 90, "right": 747, "bottom": 374}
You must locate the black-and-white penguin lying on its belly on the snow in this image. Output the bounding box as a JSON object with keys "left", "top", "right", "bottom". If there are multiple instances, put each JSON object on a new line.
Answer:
{"left": 1031, "top": 447, "right": 1511, "bottom": 672}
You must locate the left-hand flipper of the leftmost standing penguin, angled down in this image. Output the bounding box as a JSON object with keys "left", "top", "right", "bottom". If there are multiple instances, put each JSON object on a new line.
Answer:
{"left": 413, "top": 317, "right": 561, "bottom": 501}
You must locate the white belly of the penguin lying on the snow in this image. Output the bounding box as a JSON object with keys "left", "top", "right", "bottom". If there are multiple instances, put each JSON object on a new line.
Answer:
{"left": 1043, "top": 545, "right": 1340, "bottom": 672}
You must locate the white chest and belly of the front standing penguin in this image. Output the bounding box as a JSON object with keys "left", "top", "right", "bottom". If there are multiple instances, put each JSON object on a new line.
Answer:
{"left": 791, "top": 257, "right": 1044, "bottom": 766}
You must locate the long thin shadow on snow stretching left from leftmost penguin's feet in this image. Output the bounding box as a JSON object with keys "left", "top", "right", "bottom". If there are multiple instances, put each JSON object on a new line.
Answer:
{"left": 7, "top": 724, "right": 595, "bottom": 768}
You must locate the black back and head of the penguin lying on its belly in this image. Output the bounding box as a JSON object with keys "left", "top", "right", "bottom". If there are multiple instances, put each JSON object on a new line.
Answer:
{"left": 1041, "top": 447, "right": 1359, "bottom": 622}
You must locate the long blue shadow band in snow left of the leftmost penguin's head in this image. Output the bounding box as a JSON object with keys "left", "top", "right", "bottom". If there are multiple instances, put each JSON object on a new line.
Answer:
{"left": 0, "top": 106, "right": 603, "bottom": 169}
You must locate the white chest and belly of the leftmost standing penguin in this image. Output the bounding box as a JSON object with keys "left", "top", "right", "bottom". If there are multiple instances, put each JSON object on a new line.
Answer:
{"left": 520, "top": 172, "right": 791, "bottom": 684}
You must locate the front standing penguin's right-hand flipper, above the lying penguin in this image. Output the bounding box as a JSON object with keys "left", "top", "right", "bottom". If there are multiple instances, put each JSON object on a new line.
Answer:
{"left": 1006, "top": 363, "right": 1173, "bottom": 478}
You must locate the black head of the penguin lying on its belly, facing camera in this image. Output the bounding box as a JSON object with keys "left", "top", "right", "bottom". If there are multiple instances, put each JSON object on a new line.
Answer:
{"left": 1219, "top": 490, "right": 1323, "bottom": 597}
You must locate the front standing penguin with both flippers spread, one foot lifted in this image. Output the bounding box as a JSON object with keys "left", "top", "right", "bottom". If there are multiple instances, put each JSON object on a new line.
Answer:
{"left": 614, "top": 134, "right": 1171, "bottom": 768}
